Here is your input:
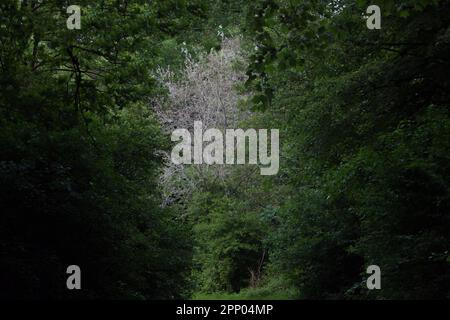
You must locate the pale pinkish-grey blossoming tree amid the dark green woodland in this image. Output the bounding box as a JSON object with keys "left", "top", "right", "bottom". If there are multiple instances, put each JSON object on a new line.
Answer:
{"left": 155, "top": 35, "right": 249, "bottom": 203}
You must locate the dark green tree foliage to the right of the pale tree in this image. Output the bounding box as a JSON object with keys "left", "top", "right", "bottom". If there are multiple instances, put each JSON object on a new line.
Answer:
{"left": 248, "top": 1, "right": 450, "bottom": 299}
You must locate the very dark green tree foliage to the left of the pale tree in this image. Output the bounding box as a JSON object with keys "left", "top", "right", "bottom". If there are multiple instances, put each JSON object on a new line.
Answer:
{"left": 0, "top": 1, "right": 199, "bottom": 299}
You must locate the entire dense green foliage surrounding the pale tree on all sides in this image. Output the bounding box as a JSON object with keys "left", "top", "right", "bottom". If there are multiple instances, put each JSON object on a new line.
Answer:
{"left": 0, "top": 0, "right": 450, "bottom": 299}
